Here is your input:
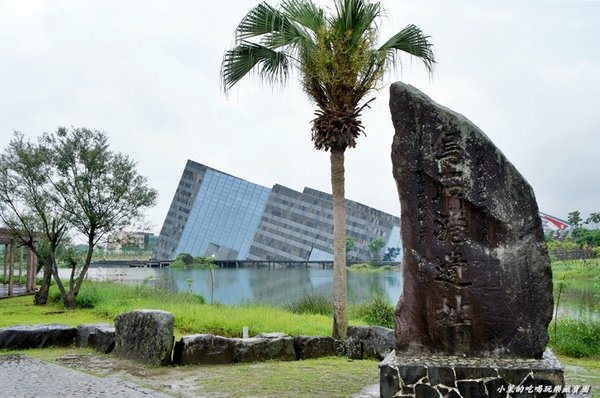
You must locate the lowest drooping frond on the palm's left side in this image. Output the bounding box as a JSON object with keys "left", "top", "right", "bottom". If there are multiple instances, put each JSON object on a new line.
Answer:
{"left": 221, "top": 41, "right": 290, "bottom": 91}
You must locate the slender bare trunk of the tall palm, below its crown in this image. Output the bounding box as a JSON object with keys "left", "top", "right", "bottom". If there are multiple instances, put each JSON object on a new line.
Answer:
{"left": 330, "top": 149, "right": 348, "bottom": 340}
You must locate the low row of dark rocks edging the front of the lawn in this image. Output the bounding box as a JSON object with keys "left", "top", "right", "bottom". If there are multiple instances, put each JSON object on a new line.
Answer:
{"left": 0, "top": 310, "right": 394, "bottom": 366}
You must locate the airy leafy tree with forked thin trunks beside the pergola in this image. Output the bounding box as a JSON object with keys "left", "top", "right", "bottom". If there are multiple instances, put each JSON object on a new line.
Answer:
{"left": 0, "top": 128, "right": 157, "bottom": 308}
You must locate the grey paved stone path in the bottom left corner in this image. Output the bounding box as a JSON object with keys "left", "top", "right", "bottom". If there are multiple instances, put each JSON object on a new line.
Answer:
{"left": 0, "top": 355, "right": 170, "bottom": 398}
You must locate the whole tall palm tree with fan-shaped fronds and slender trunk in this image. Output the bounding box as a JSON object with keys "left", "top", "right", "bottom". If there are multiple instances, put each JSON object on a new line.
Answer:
{"left": 221, "top": 0, "right": 435, "bottom": 339}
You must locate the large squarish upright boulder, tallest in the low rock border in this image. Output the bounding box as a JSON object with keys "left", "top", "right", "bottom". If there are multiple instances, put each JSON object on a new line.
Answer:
{"left": 114, "top": 310, "right": 174, "bottom": 366}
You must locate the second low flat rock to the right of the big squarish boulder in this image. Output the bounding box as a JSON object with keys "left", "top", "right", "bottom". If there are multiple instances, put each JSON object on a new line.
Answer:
{"left": 232, "top": 337, "right": 296, "bottom": 362}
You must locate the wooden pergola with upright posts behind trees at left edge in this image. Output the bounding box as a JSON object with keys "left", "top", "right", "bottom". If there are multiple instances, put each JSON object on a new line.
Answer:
{"left": 0, "top": 228, "right": 39, "bottom": 297}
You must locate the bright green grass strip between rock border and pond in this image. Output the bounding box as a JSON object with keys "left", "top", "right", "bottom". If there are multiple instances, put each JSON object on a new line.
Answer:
{"left": 0, "top": 282, "right": 364, "bottom": 337}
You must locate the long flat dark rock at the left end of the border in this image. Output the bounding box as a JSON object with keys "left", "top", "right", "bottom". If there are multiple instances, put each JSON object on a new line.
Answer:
{"left": 0, "top": 324, "right": 77, "bottom": 349}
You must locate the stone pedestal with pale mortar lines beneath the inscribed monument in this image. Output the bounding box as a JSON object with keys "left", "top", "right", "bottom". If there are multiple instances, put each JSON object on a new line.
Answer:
{"left": 379, "top": 349, "right": 566, "bottom": 398}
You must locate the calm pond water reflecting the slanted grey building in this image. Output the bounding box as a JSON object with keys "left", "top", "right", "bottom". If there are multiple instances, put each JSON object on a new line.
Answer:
{"left": 72, "top": 268, "right": 600, "bottom": 319}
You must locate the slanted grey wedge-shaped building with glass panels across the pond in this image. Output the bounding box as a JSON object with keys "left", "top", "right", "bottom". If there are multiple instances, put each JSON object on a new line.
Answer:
{"left": 152, "top": 160, "right": 401, "bottom": 261}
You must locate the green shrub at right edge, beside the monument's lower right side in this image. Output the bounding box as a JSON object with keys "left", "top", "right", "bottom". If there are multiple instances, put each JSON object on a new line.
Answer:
{"left": 548, "top": 318, "right": 600, "bottom": 358}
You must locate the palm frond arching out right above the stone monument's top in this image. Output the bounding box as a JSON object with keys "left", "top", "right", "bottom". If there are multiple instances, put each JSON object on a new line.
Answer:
{"left": 379, "top": 24, "right": 435, "bottom": 74}
